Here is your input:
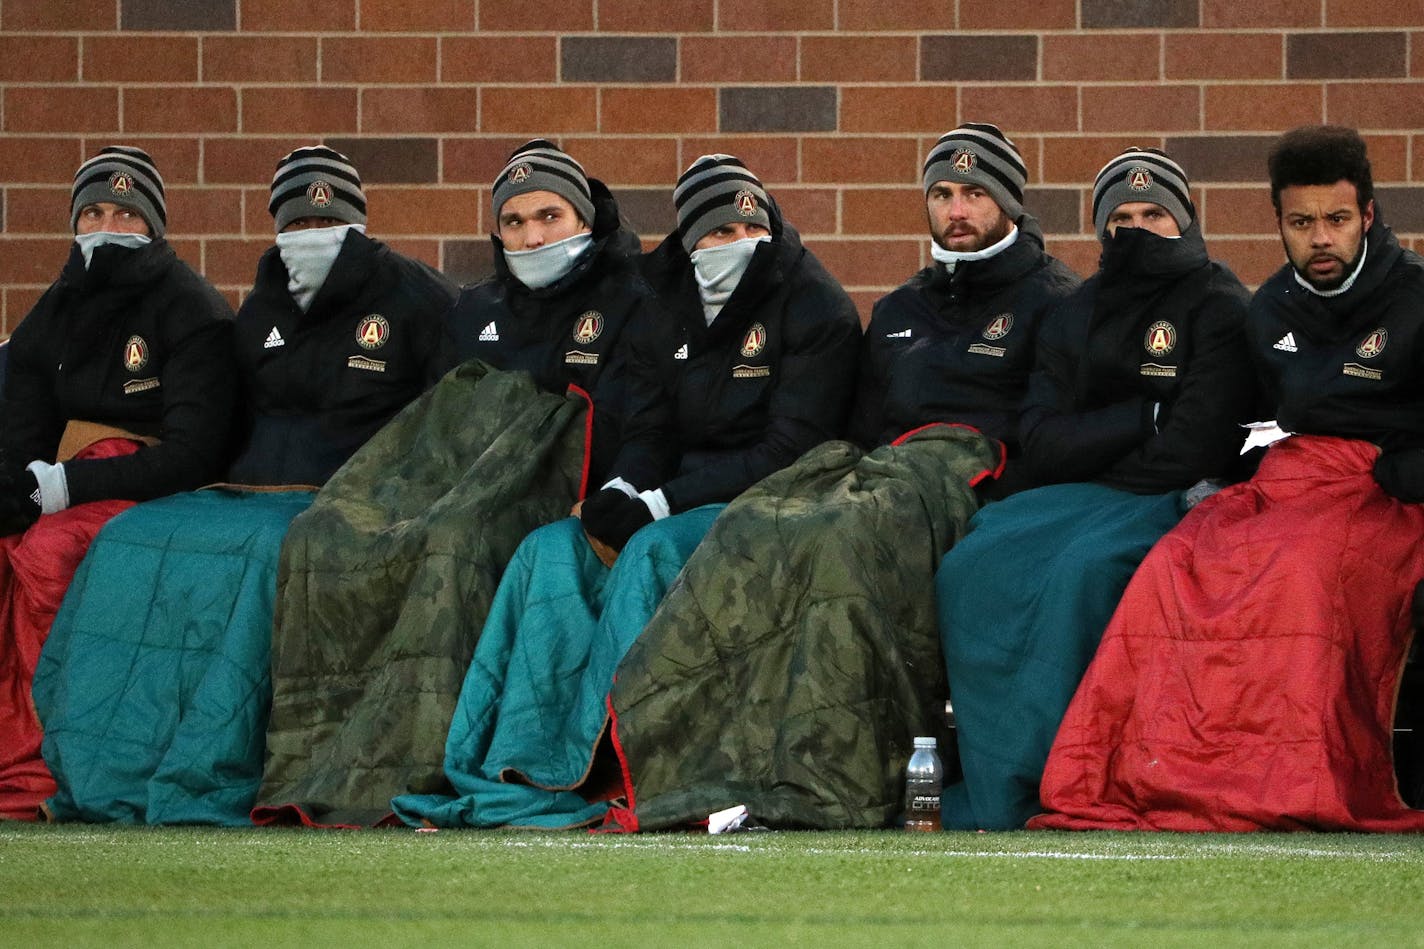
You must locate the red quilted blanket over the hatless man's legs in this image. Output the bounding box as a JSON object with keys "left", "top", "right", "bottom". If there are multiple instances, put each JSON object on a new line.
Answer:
{"left": 1030, "top": 436, "right": 1424, "bottom": 832}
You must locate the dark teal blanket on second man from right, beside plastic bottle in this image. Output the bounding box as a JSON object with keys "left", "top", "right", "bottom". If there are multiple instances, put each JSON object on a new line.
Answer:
{"left": 936, "top": 484, "right": 1182, "bottom": 831}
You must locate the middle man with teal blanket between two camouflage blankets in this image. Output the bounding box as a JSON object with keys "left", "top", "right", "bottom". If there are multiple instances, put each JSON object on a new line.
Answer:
{"left": 394, "top": 155, "right": 860, "bottom": 826}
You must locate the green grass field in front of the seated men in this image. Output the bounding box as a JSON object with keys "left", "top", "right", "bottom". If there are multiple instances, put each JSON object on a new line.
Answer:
{"left": 0, "top": 824, "right": 1424, "bottom": 949}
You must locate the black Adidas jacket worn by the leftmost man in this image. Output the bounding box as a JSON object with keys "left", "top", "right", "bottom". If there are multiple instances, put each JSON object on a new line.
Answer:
{"left": 0, "top": 239, "right": 235, "bottom": 504}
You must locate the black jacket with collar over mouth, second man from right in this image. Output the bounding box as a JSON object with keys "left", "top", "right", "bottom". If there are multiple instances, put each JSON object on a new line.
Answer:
{"left": 1020, "top": 222, "right": 1255, "bottom": 494}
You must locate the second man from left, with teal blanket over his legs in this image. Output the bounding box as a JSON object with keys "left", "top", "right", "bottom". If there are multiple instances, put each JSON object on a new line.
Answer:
{"left": 34, "top": 145, "right": 454, "bottom": 824}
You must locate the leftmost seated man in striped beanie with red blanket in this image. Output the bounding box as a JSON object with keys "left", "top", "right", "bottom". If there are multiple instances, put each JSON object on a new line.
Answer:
{"left": 0, "top": 145, "right": 234, "bottom": 819}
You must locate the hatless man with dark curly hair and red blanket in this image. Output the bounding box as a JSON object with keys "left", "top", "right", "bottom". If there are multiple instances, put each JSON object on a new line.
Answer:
{"left": 1031, "top": 127, "right": 1424, "bottom": 832}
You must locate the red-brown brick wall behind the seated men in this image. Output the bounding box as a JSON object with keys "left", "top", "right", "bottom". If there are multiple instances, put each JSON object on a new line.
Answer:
{"left": 0, "top": 0, "right": 1424, "bottom": 332}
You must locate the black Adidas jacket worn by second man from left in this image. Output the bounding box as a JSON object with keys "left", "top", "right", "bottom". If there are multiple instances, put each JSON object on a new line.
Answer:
{"left": 228, "top": 231, "right": 456, "bottom": 484}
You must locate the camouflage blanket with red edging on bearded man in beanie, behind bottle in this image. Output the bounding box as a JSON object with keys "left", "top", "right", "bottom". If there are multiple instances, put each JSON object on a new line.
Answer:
{"left": 609, "top": 426, "right": 1000, "bottom": 829}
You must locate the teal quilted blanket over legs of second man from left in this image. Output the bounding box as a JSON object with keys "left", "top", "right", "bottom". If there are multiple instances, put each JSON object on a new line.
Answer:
{"left": 34, "top": 490, "right": 313, "bottom": 825}
